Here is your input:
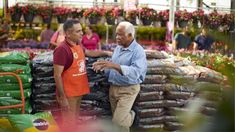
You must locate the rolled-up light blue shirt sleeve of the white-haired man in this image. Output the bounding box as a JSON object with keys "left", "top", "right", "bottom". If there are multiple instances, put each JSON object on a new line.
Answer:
{"left": 120, "top": 48, "right": 147, "bottom": 82}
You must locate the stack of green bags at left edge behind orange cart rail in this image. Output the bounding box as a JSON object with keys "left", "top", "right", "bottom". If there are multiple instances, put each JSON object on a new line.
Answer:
{"left": 0, "top": 52, "right": 32, "bottom": 115}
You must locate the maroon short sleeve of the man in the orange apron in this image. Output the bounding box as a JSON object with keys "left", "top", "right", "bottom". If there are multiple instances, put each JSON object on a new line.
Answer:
{"left": 53, "top": 47, "right": 68, "bottom": 66}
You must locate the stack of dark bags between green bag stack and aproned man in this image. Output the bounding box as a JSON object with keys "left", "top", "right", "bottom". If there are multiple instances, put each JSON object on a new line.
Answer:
{"left": 31, "top": 51, "right": 60, "bottom": 114}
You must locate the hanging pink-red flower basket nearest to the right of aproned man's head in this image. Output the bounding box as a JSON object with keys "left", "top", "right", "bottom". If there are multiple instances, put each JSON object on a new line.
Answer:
{"left": 83, "top": 7, "right": 105, "bottom": 24}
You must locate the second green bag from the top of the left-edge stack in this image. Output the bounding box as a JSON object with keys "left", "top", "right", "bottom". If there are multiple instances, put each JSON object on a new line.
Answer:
{"left": 0, "top": 64, "right": 31, "bottom": 74}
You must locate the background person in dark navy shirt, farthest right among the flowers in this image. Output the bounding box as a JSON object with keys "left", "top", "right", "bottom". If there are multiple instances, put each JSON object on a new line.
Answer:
{"left": 194, "top": 27, "right": 214, "bottom": 50}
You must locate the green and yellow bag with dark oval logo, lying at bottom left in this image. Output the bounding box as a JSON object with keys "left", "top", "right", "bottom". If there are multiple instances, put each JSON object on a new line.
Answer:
{"left": 8, "top": 112, "right": 59, "bottom": 132}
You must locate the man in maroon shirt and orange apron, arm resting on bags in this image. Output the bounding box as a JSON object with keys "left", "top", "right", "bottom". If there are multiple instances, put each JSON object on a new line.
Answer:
{"left": 53, "top": 19, "right": 111, "bottom": 131}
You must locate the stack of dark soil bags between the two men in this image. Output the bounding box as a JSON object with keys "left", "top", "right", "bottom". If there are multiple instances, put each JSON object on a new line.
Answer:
{"left": 80, "top": 57, "right": 111, "bottom": 120}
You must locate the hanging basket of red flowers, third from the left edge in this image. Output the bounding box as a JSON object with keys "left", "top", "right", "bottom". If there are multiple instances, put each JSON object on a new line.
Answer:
{"left": 38, "top": 6, "right": 53, "bottom": 24}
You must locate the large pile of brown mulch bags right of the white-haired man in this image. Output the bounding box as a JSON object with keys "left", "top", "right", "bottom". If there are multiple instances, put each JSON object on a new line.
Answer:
{"left": 133, "top": 51, "right": 224, "bottom": 131}
